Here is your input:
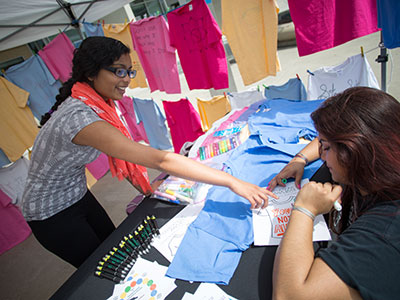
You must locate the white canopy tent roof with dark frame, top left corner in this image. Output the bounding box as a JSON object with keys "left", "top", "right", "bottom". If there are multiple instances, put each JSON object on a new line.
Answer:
{"left": 0, "top": 0, "right": 132, "bottom": 51}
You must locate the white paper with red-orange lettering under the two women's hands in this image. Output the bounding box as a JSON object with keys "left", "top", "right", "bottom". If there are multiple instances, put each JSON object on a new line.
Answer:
{"left": 253, "top": 179, "right": 331, "bottom": 246}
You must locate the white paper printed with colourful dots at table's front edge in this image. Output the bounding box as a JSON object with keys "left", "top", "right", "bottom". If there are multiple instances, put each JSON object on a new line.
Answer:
{"left": 107, "top": 257, "right": 176, "bottom": 300}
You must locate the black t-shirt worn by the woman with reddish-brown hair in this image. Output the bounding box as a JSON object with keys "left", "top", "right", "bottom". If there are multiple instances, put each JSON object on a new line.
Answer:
{"left": 316, "top": 200, "right": 400, "bottom": 299}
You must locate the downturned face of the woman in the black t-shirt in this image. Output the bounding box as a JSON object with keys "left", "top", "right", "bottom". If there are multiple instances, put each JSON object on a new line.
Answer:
{"left": 318, "top": 134, "right": 347, "bottom": 184}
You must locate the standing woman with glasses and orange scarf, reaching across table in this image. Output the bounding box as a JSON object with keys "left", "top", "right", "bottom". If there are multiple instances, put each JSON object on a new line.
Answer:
{"left": 23, "top": 37, "right": 273, "bottom": 267}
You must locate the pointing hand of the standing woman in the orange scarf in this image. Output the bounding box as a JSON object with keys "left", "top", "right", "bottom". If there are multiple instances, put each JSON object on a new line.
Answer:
{"left": 230, "top": 179, "right": 278, "bottom": 209}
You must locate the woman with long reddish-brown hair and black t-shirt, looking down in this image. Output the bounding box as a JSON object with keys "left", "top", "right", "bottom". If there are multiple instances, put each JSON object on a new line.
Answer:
{"left": 270, "top": 87, "right": 400, "bottom": 299}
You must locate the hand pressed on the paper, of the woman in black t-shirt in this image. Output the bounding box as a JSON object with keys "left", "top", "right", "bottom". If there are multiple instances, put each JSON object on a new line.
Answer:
{"left": 268, "top": 157, "right": 306, "bottom": 191}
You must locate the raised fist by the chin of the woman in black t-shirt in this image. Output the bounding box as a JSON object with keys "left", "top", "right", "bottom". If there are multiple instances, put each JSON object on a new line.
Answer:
{"left": 295, "top": 181, "right": 342, "bottom": 216}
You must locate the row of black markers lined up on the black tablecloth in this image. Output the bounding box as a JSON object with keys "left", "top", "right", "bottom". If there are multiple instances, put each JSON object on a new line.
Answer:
{"left": 95, "top": 215, "right": 160, "bottom": 283}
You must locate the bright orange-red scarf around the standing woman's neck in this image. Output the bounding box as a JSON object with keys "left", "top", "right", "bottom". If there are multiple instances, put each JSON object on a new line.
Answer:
{"left": 71, "top": 82, "right": 152, "bottom": 194}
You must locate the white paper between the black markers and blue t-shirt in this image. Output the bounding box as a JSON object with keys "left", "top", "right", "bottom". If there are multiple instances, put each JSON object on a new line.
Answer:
{"left": 152, "top": 202, "right": 204, "bottom": 261}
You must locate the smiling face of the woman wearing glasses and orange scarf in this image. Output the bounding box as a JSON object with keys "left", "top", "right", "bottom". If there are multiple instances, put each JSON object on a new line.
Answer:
{"left": 89, "top": 54, "right": 132, "bottom": 100}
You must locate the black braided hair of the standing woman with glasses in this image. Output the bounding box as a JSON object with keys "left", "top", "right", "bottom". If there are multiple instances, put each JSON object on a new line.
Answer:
{"left": 40, "top": 36, "right": 130, "bottom": 126}
